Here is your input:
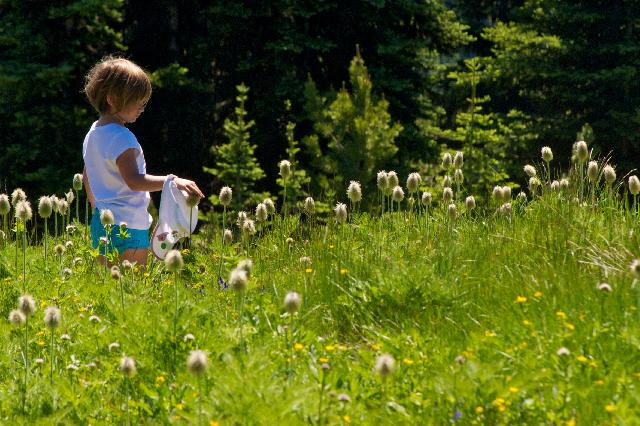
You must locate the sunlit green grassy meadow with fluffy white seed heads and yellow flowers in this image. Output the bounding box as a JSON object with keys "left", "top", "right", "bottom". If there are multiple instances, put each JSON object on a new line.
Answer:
{"left": 0, "top": 145, "right": 640, "bottom": 426}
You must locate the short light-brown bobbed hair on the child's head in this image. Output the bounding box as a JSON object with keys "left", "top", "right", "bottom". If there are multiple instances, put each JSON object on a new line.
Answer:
{"left": 84, "top": 56, "right": 151, "bottom": 114}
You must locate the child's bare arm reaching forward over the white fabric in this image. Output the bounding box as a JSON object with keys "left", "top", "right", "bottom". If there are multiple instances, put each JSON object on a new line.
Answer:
{"left": 116, "top": 148, "right": 204, "bottom": 198}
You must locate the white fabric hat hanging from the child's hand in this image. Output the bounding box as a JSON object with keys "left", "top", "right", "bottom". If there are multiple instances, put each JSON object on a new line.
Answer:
{"left": 150, "top": 175, "right": 198, "bottom": 260}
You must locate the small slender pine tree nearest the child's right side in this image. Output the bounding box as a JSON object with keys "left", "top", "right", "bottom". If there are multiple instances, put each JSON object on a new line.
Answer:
{"left": 203, "top": 84, "right": 265, "bottom": 209}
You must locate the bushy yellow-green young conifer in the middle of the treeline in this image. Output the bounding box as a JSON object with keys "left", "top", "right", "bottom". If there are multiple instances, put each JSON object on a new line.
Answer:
{"left": 305, "top": 53, "right": 402, "bottom": 200}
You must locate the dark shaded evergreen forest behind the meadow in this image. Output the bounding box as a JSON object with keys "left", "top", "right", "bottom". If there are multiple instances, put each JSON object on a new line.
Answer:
{"left": 0, "top": 0, "right": 640, "bottom": 209}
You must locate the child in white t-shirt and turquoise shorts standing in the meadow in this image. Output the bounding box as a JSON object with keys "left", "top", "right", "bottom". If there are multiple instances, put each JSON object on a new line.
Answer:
{"left": 82, "top": 57, "right": 204, "bottom": 266}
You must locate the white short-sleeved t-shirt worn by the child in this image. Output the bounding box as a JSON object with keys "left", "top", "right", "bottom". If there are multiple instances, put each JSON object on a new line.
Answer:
{"left": 82, "top": 121, "right": 151, "bottom": 229}
